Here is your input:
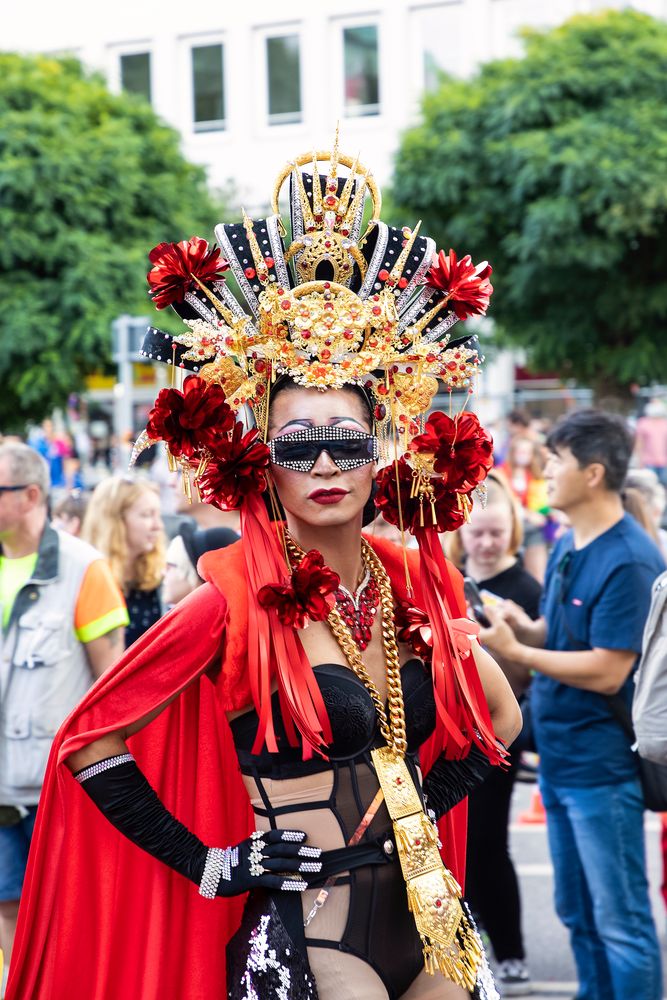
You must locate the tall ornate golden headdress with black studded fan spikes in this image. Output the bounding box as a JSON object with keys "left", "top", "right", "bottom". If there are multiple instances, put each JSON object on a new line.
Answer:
{"left": 144, "top": 130, "right": 492, "bottom": 451}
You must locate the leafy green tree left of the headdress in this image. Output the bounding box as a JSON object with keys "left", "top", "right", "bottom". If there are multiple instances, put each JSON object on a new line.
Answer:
{"left": 0, "top": 54, "right": 224, "bottom": 431}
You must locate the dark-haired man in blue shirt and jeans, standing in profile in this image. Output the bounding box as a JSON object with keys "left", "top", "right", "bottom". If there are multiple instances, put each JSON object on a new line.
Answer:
{"left": 481, "top": 410, "right": 664, "bottom": 1000}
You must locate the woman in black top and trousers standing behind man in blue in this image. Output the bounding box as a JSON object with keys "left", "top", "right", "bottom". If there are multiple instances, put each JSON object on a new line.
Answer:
{"left": 450, "top": 470, "right": 542, "bottom": 996}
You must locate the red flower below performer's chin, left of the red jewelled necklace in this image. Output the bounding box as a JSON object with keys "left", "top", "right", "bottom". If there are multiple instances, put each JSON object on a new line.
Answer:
{"left": 257, "top": 549, "right": 340, "bottom": 628}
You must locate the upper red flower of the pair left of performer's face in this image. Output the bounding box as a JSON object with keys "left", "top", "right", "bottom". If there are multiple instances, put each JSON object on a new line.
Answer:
{"left": 146, "top": 375, "right": 234, "bottom": 459}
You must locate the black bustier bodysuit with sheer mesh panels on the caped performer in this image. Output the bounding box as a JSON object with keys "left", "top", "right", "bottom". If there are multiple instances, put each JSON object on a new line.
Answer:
{"left": 231, "top": 659, "right": 435, "bottom": 1000}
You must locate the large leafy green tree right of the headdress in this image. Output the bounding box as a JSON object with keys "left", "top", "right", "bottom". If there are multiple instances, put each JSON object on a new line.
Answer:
{"left": 393, "top": 11, "right": 667, "bottom": 398}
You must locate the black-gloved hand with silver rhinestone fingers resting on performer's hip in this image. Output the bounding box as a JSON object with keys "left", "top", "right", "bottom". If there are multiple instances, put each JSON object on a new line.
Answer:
{"left": 209, "top": 830, "right": 322, "bottom": 896}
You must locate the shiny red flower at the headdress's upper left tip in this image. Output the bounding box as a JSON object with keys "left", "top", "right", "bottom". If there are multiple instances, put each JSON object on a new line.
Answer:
{"left": 146, "top": 236, "right": 229, "bottom": 309}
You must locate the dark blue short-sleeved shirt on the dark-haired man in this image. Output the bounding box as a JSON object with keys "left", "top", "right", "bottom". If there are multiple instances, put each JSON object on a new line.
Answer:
{"left": 531, "top": 514, "right": 664, "bottom": 788}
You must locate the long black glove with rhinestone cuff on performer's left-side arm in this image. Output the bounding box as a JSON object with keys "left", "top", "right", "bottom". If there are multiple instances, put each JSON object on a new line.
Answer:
{"left": 74, "top": 753, "right": 322, "bottom": 899}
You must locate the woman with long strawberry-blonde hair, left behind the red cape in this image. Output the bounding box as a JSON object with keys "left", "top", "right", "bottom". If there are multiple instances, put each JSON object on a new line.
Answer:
{"left": 82, "top": 476, "right": 165, "bottom": 646}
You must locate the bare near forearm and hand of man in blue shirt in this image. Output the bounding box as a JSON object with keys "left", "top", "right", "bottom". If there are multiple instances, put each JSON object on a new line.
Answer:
{"left": 479, "top": 608, "right": 637, "bottom": 694}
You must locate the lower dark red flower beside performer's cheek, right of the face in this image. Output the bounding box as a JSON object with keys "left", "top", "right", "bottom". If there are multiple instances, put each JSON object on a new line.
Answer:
{"left": 375, "top": 457, "right": 465, "bottom": 534}
